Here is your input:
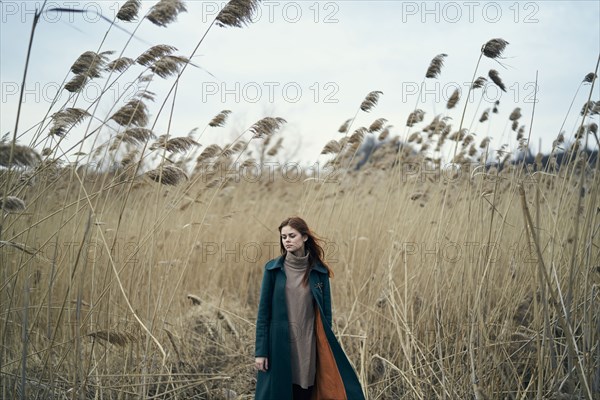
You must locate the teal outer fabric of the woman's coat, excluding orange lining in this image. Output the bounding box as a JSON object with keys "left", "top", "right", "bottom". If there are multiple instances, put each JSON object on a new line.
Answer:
{"left": 255, "top": 256, "right": 364, "bottom": 400}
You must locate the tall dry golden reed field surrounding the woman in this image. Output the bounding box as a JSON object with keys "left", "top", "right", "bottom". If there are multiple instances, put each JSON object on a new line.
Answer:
{"left": 0, "top": 0, "right": 600, "bottom": 400}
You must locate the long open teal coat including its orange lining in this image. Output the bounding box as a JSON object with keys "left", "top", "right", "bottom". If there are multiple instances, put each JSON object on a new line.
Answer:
{"left": 255, "top": 256, "right": 365, "bottom": 400}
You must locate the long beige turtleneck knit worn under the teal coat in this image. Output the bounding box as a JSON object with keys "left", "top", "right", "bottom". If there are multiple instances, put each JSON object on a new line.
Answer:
{"left": 283, "top": 251, "right": 317, "bottom": 389}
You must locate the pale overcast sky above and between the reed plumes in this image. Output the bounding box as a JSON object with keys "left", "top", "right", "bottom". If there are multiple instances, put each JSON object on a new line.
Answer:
{"left": 0, "top": 0, "right": 600, "bottom": 166}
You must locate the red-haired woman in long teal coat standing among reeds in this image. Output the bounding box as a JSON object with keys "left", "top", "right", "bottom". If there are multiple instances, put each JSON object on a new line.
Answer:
{"left": 255, "top": 217, "right": 364, "bottom": 400}
